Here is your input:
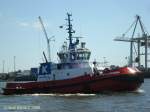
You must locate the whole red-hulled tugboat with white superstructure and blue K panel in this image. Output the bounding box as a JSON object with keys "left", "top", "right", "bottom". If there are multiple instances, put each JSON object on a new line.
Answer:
{"left": 3, "top": 13, "right": 144, "bottom": 95}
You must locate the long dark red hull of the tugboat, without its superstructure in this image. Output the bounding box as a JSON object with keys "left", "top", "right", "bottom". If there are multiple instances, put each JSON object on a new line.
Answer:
{"left": 3, "top": 68, "right": 144, "bottom": 95}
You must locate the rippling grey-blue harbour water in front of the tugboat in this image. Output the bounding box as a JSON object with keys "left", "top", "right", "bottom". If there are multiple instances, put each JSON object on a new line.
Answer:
{"left": 0, "top": 79, "right": 150, "bottom": 112}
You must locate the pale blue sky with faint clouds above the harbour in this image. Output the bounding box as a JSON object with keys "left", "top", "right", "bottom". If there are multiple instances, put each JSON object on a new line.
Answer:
{"left": 0, "top": 0, "right": 150, "bottom": 72}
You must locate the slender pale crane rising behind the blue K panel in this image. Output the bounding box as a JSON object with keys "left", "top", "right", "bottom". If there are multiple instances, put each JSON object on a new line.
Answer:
{"left": 39, "top": 16, "right": 54, "bottom": 62}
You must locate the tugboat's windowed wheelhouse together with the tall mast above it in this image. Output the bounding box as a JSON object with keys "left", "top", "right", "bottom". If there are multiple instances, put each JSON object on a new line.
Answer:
{"left": 58, "top": 13, "right": 91, "bottom": 63}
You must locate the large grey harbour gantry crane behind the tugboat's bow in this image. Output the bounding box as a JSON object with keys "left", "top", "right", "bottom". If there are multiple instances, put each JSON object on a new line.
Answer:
{"left": 114, "top": 15, "right": 150, "bottom": 70}
